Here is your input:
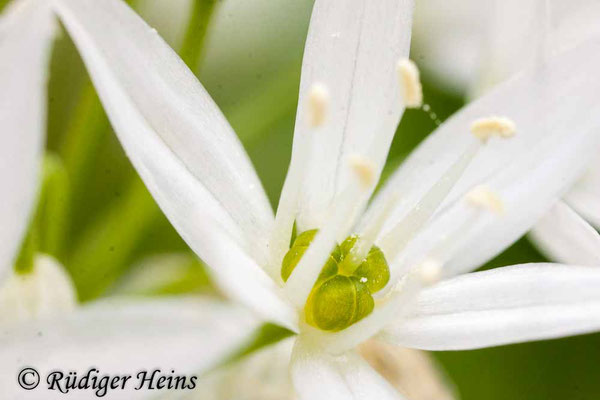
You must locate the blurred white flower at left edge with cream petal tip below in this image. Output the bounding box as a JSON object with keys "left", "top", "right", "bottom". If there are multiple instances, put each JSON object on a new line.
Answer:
{"left": 0, "top": 2, "right": 76, "bottom": 328}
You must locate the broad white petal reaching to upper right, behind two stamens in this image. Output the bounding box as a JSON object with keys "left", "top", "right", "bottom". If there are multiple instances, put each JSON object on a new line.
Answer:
{"left": 367, "top": 38, "right": 600, "bottom": 278}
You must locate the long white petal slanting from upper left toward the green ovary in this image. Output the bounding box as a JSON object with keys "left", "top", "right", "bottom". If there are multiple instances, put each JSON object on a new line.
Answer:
{"left": 56, "top": 0, "right": 272, "bottom": 263}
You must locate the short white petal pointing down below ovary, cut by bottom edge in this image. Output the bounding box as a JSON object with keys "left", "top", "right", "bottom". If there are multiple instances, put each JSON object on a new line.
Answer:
{"left": 291, "top": 339, "right": 402, "bottom": 400}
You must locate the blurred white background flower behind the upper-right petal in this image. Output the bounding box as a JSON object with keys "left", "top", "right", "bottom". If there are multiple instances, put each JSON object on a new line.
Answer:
{"left": 415, "top": 0, "right": 600, "bottom": 265}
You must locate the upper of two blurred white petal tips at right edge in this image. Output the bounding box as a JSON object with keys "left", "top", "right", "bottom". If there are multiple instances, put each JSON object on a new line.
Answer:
{"left": 565, "top": 158, "right": 600, "bottom": 229}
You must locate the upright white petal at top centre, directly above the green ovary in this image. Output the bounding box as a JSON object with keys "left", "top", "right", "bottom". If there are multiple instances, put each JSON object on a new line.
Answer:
{"left": 281, "top": 0, "right": 413, "bottom": 231}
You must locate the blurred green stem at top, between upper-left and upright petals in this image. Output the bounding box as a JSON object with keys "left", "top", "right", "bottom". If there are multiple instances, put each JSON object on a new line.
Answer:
{"left": 179, "top": 0, "right": 217, "bottom": 72}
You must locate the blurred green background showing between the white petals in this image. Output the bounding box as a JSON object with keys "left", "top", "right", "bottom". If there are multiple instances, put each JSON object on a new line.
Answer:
{"left": 0, "top": 0, "right": 600, "bottom": 400}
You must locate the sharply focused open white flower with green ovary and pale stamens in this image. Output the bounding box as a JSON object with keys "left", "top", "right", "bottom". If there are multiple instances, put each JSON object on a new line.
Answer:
{"left": 0, "top": 0, "right": 600, "bottom": 400}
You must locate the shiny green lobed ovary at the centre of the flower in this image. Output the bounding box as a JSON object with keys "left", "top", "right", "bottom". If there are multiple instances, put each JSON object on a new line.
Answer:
{"left": 281, "top": 229, "right": 390, "bottom": 331}
